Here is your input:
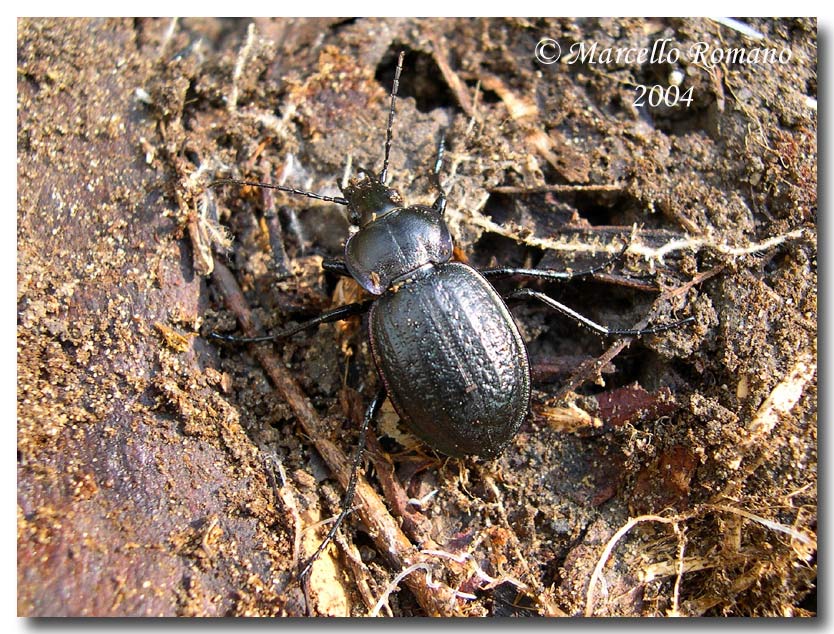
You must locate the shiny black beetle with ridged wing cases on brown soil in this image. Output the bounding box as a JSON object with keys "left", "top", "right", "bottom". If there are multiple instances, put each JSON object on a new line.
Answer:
{"left": 210, "top": 52, "right": 694, "bottom": 577}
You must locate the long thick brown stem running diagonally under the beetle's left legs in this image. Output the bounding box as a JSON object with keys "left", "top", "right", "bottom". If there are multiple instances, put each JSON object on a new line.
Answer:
{"left": 212, "top": 262, "right": 454, "bottom": 616}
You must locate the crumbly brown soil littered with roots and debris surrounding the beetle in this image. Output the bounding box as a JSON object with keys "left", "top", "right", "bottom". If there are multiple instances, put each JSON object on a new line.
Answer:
{"left": 17, "top": 19, "right": 817, "bottom": 616}
